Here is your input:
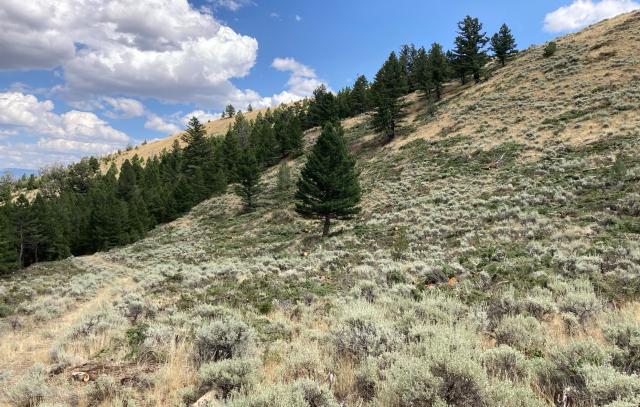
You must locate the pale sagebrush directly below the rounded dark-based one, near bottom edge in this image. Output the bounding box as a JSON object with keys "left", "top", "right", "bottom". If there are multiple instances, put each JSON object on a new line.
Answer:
{"left": 198, "top": 359, "right": 257, "bottom": 399}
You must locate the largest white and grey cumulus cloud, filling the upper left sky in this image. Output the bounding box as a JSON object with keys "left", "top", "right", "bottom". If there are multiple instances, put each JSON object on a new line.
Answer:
{"left": 0, "top": 0, "right": 258, "bottom": 105}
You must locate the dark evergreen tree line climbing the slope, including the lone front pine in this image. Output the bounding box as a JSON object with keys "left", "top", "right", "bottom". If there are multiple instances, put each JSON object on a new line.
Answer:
{"left": 0, "top": 16, "right": 516, "bottom": 273}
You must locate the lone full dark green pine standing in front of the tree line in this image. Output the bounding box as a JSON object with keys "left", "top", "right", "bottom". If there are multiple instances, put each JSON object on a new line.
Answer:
{"left": 296, "top": 123, "right": 361, "bottom": 236}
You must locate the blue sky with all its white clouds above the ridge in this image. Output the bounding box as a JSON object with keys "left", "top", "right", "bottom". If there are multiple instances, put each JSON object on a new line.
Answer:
{"left": 0, "top": 0, "right": 640, "bottom": 169}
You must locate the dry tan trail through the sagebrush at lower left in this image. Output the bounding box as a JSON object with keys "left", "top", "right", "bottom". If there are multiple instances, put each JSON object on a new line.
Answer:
{"left": 0, "top": 254, "right": 135, "bottom": 388}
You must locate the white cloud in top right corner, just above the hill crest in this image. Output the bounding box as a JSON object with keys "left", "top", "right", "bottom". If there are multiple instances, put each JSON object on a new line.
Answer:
{"left": 544, "top": 0, "right": 640, "bottom": 33}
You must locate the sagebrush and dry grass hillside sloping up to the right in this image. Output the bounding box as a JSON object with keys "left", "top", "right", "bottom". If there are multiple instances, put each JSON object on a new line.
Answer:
{"left": 0, "top": 13, "right": 640, "bottom": 407}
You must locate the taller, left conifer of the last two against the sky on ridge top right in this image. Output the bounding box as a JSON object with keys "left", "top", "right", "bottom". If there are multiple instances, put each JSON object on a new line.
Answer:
{"left": 453, "top": 16, "right": 489, "bottom": 83}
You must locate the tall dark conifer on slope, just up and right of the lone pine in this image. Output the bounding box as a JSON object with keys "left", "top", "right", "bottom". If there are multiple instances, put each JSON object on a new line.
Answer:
{"left": 372, "top": 52, "right": 406, "bottom": 142}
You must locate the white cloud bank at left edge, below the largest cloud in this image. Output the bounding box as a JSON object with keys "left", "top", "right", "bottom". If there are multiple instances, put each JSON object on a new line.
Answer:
{"left": 0, "top": 92, "right": 129, "bottom": 165}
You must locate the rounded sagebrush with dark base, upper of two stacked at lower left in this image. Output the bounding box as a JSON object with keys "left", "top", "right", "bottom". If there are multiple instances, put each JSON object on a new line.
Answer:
{"left": 195, "top": 318, "right": 255, "bottom": 363}
